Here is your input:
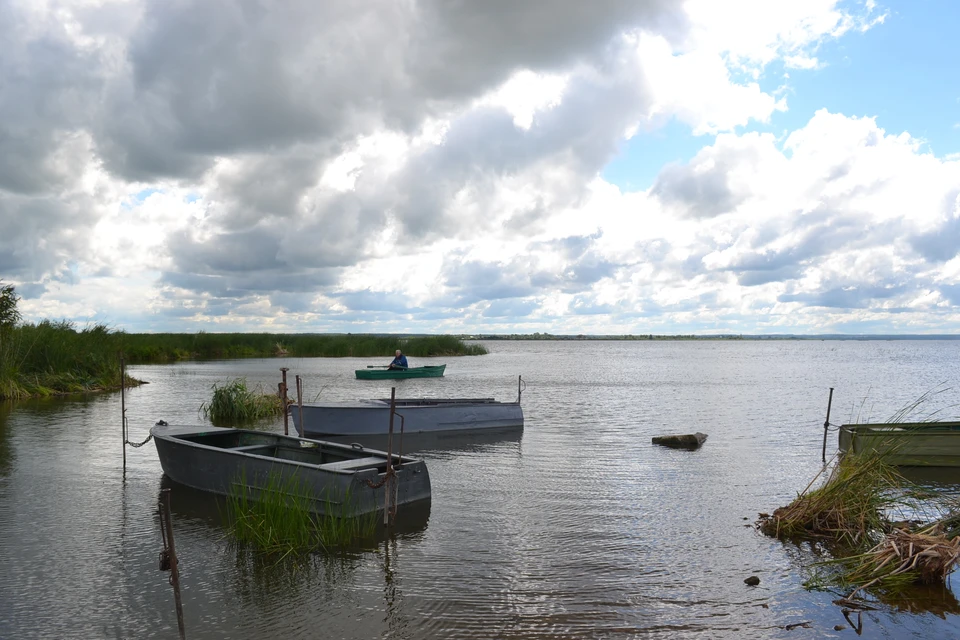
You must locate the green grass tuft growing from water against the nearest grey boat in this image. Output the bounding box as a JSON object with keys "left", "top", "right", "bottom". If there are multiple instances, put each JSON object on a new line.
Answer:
{"left": 226, "top": 472, "right": 377, "bottom": 556}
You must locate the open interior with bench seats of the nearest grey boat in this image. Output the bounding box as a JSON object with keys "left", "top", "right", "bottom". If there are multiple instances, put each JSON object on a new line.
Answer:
{"left": 174, "top": 431, "right": 400, "bottom": 472}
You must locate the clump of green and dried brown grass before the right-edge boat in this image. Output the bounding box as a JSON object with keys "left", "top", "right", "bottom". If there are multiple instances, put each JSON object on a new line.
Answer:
{"left": 757, "top": 451, "right": 960, "bottom": 603}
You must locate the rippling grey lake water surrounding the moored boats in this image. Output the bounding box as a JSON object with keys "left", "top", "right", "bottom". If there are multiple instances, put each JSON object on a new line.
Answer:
{"left": 0, "top": 340, "right": 960, "bottom": 639}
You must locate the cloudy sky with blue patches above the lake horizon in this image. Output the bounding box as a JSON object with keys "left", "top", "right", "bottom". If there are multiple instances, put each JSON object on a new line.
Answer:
{"left": 0, "top": 0, "right": 960, "bottom": 335}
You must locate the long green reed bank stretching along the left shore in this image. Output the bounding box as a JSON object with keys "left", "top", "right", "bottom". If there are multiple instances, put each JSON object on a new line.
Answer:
{"left": 0, "top": 282, "right": 487, "bottom": 400}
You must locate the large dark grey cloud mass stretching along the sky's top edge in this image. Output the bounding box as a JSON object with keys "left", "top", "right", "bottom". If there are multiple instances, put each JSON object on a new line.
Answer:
{"left": 98, "top": 0, "right": 686, "bottom": 184}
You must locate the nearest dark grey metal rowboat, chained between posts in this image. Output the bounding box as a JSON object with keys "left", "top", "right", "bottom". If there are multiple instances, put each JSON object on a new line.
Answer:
{"left": 150, "top": 422, "right": 430, "bottom": 515}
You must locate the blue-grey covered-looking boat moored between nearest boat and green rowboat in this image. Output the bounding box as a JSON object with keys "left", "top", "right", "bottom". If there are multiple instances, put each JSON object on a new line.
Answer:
{"left": 290, "top": 398, "right": 523, "bottom": 438}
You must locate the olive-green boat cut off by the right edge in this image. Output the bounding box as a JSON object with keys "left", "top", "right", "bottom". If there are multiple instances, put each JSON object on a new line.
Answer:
{"left": 839, "top": 422, "right": 960, "bottom": 467}
